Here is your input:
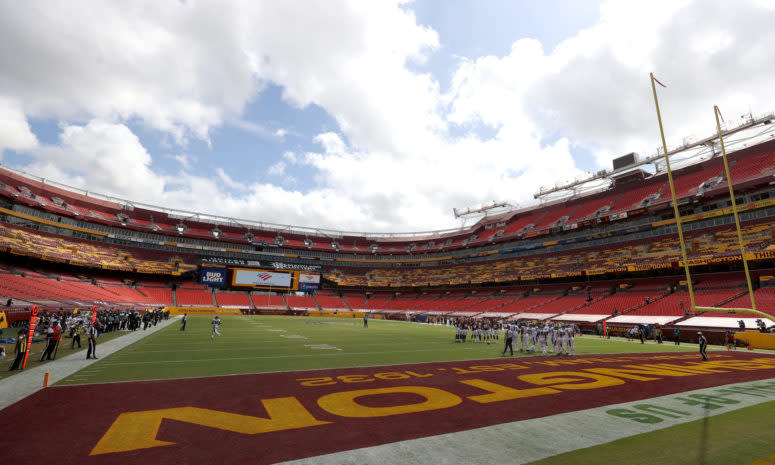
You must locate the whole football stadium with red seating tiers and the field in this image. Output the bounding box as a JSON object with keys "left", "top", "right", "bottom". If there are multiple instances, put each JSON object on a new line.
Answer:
{"left": 0, "top": 0, "right": 775, "bottom": 465}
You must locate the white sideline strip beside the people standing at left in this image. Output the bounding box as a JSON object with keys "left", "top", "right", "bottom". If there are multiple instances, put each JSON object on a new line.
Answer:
{"left": 0, "top": 316, "right": 180, "bottom": 410}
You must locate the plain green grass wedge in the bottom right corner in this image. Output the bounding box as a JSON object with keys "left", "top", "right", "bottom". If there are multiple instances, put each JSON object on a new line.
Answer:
{"left": 532, "top": 402, "right": 775, "bottom": 465}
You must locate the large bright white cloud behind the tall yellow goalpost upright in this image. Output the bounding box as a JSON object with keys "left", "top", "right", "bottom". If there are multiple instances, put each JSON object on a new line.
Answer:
{"left": 526, "top": 1, "right": 775, "bottom": 167}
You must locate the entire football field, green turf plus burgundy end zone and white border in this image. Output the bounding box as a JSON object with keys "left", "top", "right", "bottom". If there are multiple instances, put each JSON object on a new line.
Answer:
{"left": 0, "top": 316, "right": 775, "bottom": 465}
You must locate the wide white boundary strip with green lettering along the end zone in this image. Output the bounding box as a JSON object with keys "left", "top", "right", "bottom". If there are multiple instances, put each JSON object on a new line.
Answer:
{"left": 277, "top": 378, "right": 775, "bottom": 465}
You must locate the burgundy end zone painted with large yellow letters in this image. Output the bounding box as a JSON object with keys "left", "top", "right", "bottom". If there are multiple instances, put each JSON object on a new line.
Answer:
{"left": 0, "top": 352, "right": 775, "bottom": 465}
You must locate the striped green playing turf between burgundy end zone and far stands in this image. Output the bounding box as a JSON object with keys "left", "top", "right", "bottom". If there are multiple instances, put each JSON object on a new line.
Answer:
{"left": 57, "top": 316, "right": 708, "bottom": 384}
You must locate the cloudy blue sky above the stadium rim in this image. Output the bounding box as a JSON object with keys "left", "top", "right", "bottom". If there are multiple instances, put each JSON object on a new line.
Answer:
{"left": 0, "top": 0, "right": 773, "bottom": 231}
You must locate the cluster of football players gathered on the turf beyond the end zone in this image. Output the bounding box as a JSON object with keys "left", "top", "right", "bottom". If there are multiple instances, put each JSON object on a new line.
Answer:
{"left": 455, "top": 318, "right": 576, "bottom": 355}
